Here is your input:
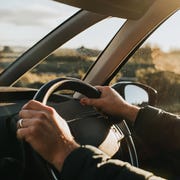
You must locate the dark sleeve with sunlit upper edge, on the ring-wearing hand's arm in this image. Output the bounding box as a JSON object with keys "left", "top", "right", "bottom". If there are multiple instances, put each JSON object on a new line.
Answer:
{"left": 61, "top": 146, "right": 165, "bottom": 180}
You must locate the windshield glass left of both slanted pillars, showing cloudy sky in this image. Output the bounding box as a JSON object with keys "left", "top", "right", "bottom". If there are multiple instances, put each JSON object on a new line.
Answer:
{"left": 0, "top": 0, "right": 79, "bottom": 72}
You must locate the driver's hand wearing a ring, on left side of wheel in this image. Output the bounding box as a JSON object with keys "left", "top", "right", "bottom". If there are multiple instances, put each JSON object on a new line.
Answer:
{"left": 17, "top": 100, "right": 79, "bottom": 171}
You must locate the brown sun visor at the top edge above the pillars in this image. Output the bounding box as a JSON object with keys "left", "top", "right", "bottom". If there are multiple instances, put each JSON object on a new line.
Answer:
{"left": 55, "top": 0, "right": 155, "bottom": 19}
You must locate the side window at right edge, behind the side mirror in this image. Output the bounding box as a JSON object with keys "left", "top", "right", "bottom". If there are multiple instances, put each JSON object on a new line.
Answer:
{"left": 112, "top": 11, "right": 180, "bottom": 114}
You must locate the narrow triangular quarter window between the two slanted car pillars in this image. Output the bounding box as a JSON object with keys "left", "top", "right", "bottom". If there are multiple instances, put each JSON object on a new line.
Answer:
{"left": 15, "top": 18, "right": 125, "bottom": 88}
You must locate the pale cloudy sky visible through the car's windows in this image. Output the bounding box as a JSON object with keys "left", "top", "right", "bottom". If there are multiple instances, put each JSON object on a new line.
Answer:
{"left": 0, "top": 0, "right": 180, "bottom": 50}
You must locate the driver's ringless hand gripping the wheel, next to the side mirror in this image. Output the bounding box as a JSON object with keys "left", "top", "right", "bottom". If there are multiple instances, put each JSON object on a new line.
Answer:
{"left": 80, "top": 86, "right": 139, "bottom": 121}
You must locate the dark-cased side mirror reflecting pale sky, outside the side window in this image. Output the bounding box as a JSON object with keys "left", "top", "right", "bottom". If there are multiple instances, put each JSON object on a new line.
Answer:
{"left": 112, "top": 82, "right": 157, "bottom": 106}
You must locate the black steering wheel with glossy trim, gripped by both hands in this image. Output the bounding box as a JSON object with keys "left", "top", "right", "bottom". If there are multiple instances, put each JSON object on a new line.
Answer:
{"left": 24, "top": 78, "right": 136, "bottom": 179}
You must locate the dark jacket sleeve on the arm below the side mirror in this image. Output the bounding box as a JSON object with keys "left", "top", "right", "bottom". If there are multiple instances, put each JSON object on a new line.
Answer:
{"left": 134, "top": 106, "right": 180, "bottom": 152}
